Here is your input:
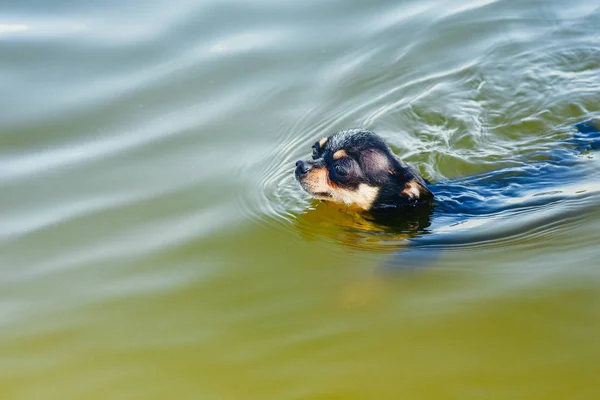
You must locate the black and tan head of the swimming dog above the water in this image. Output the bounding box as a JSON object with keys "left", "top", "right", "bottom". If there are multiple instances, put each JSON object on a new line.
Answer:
{"left": 295, "top": 129, "right": 433, "bottom": 210}
